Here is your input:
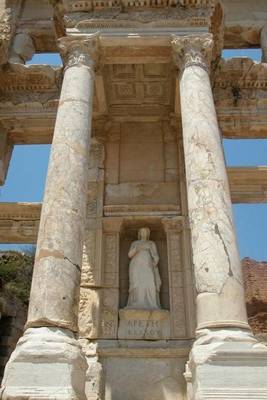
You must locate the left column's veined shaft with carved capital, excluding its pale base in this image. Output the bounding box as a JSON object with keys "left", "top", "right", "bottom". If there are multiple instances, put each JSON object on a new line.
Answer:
{"left": 27, "top": 37, "right": 97, "bottom": 331}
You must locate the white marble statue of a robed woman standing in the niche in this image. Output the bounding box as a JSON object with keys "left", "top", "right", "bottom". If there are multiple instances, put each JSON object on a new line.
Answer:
{"left": 126, "top": 228, "right": 161, "bottom": 310}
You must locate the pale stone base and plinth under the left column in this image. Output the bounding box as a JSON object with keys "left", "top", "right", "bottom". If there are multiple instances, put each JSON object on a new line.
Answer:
{"left": 0, "top": 328, "right": 87, "bottom": 400}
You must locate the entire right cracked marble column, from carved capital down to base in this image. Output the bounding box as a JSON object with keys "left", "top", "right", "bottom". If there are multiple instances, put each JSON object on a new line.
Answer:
{"left": 173, "top": 34, "right": 267, "bottom": 400}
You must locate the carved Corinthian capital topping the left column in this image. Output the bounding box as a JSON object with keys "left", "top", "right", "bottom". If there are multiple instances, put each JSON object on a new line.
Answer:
{"left": 58, "top": 34, "right": 99, "bottom": 71}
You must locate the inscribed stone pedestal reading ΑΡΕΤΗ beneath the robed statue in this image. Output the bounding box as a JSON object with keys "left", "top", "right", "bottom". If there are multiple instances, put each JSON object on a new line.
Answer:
{"left": 118, "top": 308, "right": 170, "bottom": 340}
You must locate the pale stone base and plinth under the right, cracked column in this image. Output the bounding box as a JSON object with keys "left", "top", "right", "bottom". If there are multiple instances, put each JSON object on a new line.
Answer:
{"left": 185, "top": 328, "right": 267, "bottom": 400}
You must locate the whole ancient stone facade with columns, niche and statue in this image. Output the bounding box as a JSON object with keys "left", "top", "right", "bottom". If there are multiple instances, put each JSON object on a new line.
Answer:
{"left": 0, "top": 0, "right": 267, "bottom": 400}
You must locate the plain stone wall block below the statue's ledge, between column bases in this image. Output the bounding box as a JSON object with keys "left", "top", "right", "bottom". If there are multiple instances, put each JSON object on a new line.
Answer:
{"left": 102, "top": 348, "right": 186, "bottom": 400}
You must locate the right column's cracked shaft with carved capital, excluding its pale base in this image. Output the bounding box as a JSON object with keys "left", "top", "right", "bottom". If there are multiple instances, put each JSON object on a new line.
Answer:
{"left": 172, "top": 34, "right": 248, "bottom": 329}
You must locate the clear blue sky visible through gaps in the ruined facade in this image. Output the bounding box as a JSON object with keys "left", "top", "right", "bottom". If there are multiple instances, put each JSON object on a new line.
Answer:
{"left": 0, "top": 49, "right": 267, "bottom": 260}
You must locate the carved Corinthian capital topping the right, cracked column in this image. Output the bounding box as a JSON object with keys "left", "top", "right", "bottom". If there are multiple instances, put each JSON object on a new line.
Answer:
{"left": 171, "top": 33, "right": 213, "bottom": 71}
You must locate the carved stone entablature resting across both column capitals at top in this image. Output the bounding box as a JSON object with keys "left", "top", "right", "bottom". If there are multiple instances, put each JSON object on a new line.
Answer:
{"left": 50, "top": 0, "right": 218, "bottom": 33}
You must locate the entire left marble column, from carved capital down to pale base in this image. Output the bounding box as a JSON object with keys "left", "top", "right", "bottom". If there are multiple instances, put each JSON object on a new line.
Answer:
{"left": 0, "top": 36, "right": 98, "bottom": 400}
